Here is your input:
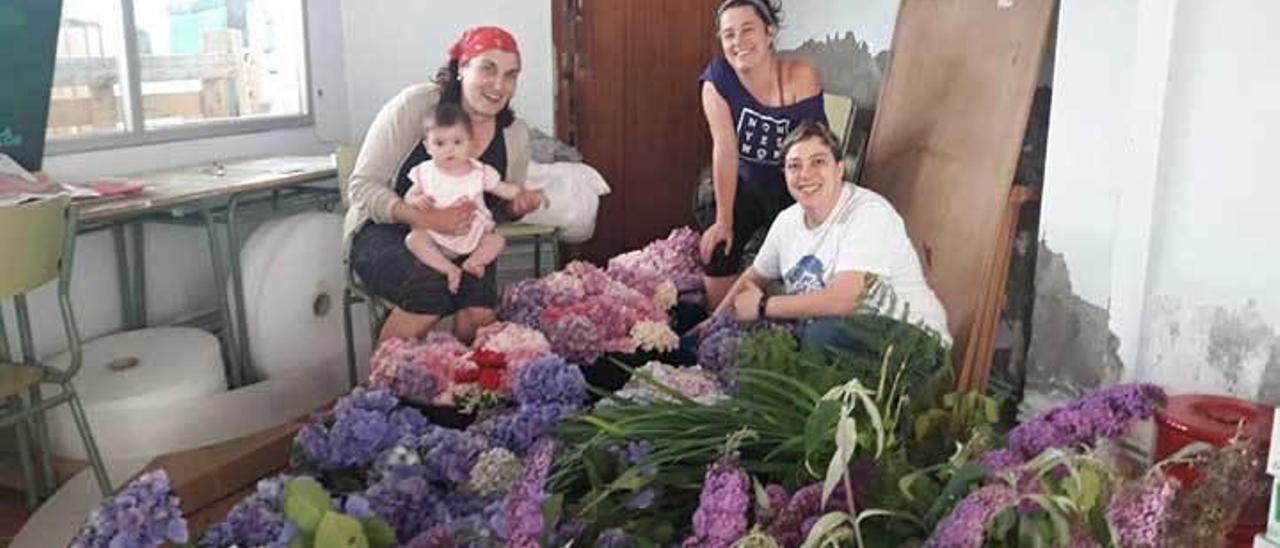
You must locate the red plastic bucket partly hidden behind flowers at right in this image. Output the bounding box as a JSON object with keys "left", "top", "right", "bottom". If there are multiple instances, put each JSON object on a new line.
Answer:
{"left": 1156, "top": 394, "right": 1272, "bottom": 547}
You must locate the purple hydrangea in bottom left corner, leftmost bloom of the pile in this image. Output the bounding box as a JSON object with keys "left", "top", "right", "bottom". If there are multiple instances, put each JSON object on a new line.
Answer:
{"left": 70, "top": 470, "right": 187, "bottom": 548}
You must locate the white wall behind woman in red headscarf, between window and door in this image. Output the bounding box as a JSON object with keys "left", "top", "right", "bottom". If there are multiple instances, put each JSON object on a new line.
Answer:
{"left": 342, "top": 0, "right": 556, "bottom": 141}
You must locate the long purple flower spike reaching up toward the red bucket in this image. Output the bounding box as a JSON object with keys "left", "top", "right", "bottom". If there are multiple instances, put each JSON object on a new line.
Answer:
{"left": 983, "top": 384, "right": 1165, "bottom": 472}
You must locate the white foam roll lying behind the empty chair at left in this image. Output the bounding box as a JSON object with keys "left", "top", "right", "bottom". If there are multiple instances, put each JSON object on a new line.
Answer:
{"left": 50, "top": 328, "right": 227, "bottom": 458}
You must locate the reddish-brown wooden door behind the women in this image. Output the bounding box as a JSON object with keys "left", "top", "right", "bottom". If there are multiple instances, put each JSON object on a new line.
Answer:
{"left": 552, "top": 0, "right": 719, "bottom": 261}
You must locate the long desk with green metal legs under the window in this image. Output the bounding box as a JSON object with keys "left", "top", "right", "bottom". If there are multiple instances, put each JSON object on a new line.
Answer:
{"left": 77, "top": 155, "right": 340, "bottom": 388}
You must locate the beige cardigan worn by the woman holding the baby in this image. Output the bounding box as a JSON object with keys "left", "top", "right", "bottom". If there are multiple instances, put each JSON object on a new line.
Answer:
{"left": 342, "top": 83, "right": 530, "bottom": 257}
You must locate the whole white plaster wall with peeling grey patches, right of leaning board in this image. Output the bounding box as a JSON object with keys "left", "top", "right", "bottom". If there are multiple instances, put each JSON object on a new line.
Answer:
{"left": 1028, "top": 0, "right": 1280, "bottom": 398}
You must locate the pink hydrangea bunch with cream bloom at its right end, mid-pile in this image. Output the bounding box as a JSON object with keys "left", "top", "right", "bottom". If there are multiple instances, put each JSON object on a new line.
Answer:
{"left": 498, "top": 262, "right": 678, "bottom": 365}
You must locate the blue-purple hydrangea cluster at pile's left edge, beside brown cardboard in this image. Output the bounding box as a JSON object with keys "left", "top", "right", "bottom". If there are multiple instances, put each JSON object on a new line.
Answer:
{"left": 294, "top": 388, "right": 428, "bottom": 471}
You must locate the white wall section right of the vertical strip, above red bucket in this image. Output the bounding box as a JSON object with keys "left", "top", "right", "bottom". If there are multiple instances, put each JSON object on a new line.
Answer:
{"left": 1137, "top": 0, "right": 1280, "bottom": 396}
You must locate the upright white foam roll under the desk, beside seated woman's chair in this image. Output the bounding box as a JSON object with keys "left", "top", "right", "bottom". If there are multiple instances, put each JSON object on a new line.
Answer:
{"left": 241, "top": 213, "right": 348, "bottom": 379}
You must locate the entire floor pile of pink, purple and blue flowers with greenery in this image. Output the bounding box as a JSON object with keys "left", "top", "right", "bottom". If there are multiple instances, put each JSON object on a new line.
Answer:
{"left": 72, "top": 229, "right": 1262, "bottom": 548}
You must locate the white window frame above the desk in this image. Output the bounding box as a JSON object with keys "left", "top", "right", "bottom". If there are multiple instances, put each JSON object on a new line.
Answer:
{"left": 45, "top": 0, "right": 315, "bottom": 156}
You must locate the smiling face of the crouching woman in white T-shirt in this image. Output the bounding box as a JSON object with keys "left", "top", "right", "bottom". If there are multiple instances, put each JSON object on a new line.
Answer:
{"left": 783, "top": 137, "right": 845, "bottom": 216}
